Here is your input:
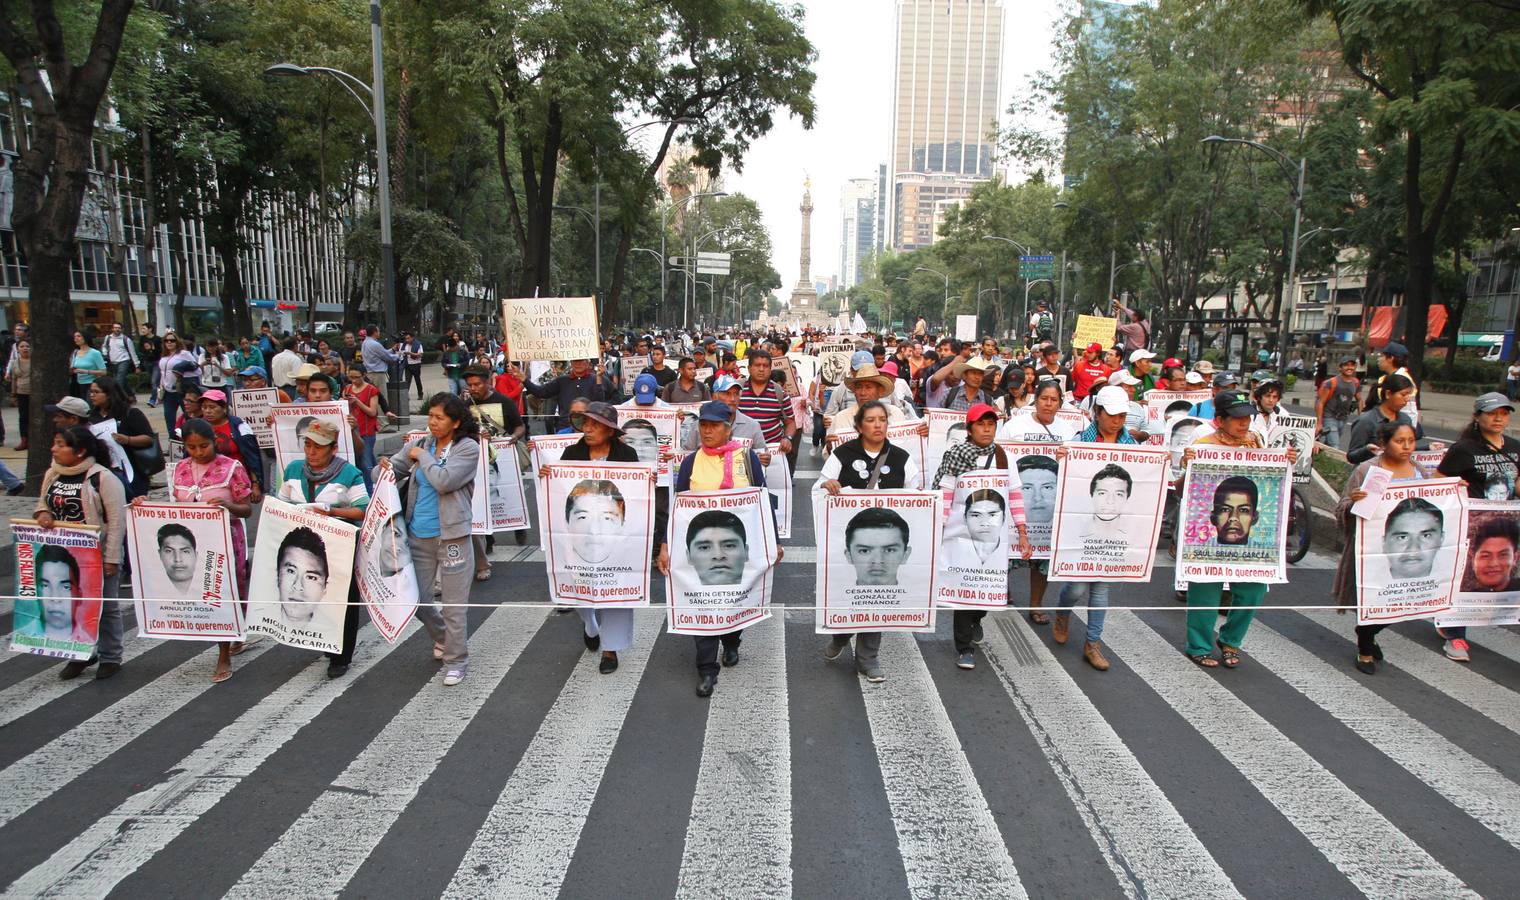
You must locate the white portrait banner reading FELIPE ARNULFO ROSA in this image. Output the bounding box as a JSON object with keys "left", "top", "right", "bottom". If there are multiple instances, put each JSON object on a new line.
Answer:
{"left": 126, "top": 503, "right": 243, "bottom": 640}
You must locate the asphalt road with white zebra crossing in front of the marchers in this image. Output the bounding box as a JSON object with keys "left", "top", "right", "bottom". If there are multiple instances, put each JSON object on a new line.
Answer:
{"left": 0, "top": 468, "right": 1520, "bottom": 898}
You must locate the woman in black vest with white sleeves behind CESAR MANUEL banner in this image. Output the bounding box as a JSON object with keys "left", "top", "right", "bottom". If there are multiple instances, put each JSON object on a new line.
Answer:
{"left": 813, "top": 400, "right": 924, "bottom": 684}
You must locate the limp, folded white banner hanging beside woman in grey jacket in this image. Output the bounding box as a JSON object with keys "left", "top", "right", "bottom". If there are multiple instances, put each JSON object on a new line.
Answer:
{"left": 359, "top": 467, "right": 418, "bottom": 643}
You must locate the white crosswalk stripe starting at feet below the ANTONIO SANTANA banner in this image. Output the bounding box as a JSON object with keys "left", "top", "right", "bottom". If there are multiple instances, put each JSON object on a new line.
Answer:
{"left": 444, "top": 622, "right": 664, "bottom": 900}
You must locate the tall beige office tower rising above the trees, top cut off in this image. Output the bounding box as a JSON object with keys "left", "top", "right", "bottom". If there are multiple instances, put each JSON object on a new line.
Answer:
{"left": 888, "top": 0, "right": 1003, "bottom": 251}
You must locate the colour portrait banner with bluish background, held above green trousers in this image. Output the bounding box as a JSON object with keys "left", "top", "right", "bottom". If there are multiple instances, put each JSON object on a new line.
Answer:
{"left": 1176, "top": 444, "right": 1290, "bottom": 584}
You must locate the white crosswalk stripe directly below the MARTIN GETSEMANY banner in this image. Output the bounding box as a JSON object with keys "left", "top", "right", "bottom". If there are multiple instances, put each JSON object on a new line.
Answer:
{"left": 675, "top": 614, "right": 792, "bottom": 900}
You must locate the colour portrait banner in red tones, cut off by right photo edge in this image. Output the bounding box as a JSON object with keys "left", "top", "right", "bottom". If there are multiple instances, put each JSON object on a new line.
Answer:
{"left": 1435, "top": 497, "right": 1520, "bottom": 628}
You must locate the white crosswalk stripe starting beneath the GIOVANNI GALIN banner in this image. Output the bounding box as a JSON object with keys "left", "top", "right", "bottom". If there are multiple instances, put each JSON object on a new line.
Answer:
{"left": 982, "top": 617, "right": 1242, "bottom": 898}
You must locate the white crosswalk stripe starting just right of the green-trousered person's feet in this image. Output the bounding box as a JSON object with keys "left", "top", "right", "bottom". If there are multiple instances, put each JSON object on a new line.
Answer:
{"left": 1251, "top": 623, "right": 1520, "bottom": 845}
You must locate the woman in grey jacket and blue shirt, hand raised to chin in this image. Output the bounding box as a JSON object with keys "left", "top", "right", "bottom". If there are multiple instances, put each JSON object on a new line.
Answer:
{"left": 380, "top": 394, "right": 480, "bottom": 687}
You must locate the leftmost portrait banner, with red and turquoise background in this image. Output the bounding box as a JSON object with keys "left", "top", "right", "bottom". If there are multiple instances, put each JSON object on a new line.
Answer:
{"left": 11, "top": 519, "right": 103, "bottom": 660}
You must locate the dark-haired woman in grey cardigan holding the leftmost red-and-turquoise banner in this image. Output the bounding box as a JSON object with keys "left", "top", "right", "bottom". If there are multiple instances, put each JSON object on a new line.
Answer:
{"left": 32, "top": 426, "right": 126, "bottom": 681}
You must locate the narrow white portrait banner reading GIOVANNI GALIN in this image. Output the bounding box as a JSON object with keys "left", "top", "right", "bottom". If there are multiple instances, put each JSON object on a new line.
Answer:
{"left": 935, "top": 471, "right": 1012, "bottom": 610}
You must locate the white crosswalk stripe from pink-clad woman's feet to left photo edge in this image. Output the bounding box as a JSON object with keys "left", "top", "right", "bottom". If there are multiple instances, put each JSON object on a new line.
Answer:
{"left": 0, "top": 640, "right": 274, "bottom": 826}
